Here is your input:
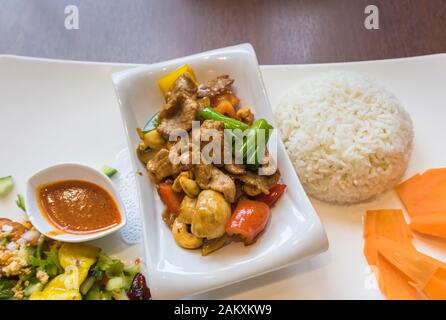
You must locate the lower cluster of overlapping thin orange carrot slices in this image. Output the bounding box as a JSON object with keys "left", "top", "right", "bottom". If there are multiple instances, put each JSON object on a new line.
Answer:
{"left": 364, "top": 210, "right": 446, "bottom": 300}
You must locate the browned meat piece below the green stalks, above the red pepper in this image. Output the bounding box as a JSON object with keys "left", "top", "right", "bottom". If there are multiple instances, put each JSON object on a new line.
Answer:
{"left": 233, "top": 170, "right": 280, "bottom": 196}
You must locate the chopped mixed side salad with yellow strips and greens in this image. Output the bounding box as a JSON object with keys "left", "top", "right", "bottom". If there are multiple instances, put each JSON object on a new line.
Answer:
{"left": 0, "top": 218, "right": 150, "bottom": 300}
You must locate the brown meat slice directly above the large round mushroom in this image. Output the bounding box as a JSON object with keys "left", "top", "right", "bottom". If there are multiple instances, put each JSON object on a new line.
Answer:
{"left": 194, "top": 164, "right": 236, "bottom": 203}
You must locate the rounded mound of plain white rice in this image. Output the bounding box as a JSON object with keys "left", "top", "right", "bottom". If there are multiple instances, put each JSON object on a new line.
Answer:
{"left": 275, "top": 72, "right": 413, "bottom": 204}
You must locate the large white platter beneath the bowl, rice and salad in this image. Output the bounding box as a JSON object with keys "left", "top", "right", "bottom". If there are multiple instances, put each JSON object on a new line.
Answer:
{"left": 0, "top": 54, "right": 446, "bottom": 299}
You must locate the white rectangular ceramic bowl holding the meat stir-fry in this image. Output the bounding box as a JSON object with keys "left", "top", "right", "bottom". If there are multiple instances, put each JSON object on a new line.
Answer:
{"left": 113, "top": 44, "right": 328, "bottom": 299}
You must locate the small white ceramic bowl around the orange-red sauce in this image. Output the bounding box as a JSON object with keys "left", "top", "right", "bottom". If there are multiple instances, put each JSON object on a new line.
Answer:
{"left": 25, "top": 163, "right": 126, "bottom": 242}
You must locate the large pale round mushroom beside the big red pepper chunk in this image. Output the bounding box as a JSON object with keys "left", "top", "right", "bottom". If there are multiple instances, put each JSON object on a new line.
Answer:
{"left": 191, "top": 190, "right": 231, "bottom": 240}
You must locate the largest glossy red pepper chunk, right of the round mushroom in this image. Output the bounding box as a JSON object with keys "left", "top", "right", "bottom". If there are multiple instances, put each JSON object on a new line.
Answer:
{"left": 226, "top": 200, "right": 270, "bottom": 245}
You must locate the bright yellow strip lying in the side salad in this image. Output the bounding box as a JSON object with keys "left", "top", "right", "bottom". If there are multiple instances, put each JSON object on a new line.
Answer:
{"left": 29, "top": 243, "right": 99, "bottom": 300}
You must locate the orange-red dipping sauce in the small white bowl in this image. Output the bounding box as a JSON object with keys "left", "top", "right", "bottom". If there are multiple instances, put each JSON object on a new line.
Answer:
{"left": 37, "top": 180, "right": 121, "bottom": 234}
